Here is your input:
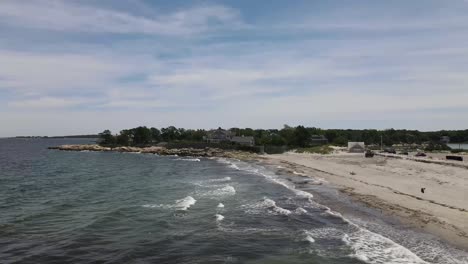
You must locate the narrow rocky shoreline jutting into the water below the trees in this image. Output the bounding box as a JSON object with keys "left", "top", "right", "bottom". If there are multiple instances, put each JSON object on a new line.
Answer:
{"left": 48, "top": 144, "right": 256, "bottom": 159}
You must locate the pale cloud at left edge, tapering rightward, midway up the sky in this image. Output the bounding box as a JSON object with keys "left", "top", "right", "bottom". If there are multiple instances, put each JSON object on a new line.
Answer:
{"left": 0, "top": 50, "right": 134, "bottom": 91}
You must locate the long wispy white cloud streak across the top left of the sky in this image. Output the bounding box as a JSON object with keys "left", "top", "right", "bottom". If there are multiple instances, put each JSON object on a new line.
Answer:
{"left": 0, "top": 0, "right": 242, "bottom": 35}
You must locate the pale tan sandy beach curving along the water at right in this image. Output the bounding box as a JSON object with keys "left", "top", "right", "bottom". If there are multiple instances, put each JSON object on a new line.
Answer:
{"left": 266, "top": 153, "right": 468, "bottom": 250}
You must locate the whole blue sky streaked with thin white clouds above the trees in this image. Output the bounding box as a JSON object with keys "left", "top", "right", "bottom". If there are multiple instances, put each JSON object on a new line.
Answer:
{"left": 0, "top": 0, "right": 468, "bottom": 137}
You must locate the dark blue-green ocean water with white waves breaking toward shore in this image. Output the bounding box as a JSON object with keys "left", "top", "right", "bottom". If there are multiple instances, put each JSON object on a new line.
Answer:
{"left": 0, "top": 139, "right": 468, "bottom": 264}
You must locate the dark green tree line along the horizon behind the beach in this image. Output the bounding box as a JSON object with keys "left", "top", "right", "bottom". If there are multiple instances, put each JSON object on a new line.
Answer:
{"left": 99, "top": 125, "right": 468, "bottom": 147}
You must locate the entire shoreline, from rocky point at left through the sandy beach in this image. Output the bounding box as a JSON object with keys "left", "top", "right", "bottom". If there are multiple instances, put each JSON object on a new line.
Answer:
{"left": 49, "top": 145, "right": 468, "bottom": 251}
